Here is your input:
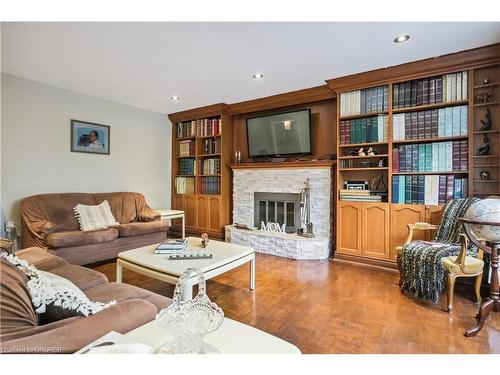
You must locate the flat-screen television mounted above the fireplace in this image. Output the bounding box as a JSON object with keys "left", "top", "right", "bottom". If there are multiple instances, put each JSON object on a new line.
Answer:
{"left": 247, "top": 109, "right": 311, "bottom": 157}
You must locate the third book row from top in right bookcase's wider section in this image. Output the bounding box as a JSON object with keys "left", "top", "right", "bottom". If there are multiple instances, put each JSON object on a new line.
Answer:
{"left": 392, "top": 141, "right": 469, "bottom": 172}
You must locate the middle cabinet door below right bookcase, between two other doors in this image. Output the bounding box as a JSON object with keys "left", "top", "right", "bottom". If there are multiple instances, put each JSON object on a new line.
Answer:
{"left": 361, "top": 203, "right": 389, "bottom": 259}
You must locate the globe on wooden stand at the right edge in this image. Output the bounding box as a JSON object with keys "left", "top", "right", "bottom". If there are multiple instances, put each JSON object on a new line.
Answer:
{"left": 464, "top": 197, "right": 500, "bottom": 242}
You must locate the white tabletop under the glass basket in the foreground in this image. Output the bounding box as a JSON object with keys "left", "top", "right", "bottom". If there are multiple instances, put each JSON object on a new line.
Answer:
{"left": 125, "top": 318, "right": 300, "bottom": 354}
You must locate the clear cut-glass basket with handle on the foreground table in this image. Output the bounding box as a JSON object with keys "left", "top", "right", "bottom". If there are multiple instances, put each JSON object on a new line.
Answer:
{"left": 153, "top": 268, "right": 224, "bottom": 354}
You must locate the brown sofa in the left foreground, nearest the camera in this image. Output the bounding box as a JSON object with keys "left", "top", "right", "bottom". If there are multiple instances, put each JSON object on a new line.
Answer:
{"left": 0, "top": 248, "right": 171, "bottom": 353}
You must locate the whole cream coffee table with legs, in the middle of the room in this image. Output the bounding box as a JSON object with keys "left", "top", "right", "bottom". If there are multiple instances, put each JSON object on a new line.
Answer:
{"left": 116, "top": 237, "right": 255, "bottom": 299}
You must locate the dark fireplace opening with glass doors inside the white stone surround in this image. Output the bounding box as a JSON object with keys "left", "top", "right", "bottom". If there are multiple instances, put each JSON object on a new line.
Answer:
{"left": 254, "top": 192, "right": 300, "bottom": 233}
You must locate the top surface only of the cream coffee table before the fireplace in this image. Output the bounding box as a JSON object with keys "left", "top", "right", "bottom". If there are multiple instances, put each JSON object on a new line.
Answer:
{"left": 118, "top": 237, "right": 254, "bottom": 277}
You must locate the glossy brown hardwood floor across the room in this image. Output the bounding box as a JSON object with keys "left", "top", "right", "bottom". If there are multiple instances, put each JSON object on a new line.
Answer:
{"left": 94, "top": 254, "right": 500, "bottom": 353}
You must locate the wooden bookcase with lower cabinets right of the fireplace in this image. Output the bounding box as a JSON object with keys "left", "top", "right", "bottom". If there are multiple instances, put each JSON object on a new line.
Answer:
{"left": 327, "top": 48, "right": 500, "bottom": 266}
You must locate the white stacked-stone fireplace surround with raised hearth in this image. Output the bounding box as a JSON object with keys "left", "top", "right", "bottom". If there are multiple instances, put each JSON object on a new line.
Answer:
{"left": 226, "top": 166, "right": 332, "bottom": 259}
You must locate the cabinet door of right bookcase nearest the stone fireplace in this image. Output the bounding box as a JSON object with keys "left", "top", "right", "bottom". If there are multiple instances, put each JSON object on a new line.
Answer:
{"left": 337, "top": 202, "right": 362, "bottom": 255}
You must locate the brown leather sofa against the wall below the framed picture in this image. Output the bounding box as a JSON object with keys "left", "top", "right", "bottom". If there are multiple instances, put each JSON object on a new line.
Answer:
{"left": 21, "top": 192, "right": 168, "bottom": 264}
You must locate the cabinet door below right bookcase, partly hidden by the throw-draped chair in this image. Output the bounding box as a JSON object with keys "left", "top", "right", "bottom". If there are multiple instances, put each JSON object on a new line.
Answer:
{"left": 389, "top": 204, "right": 426, "bottom": 260}
